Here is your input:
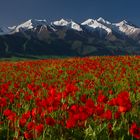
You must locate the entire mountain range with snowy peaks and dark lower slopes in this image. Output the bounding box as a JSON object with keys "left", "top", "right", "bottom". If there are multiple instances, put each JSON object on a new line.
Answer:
{"left": 0, "top": 17, "right": 140, "bottom": 57}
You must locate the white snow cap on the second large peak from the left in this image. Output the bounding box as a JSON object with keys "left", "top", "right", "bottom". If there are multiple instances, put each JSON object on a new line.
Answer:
{"left": 51, "top": 19, "right": 82, "bottom": 31}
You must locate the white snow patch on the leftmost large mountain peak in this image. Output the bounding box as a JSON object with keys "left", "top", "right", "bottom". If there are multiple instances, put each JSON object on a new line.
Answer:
{"left": 15, "top": 19, "right": 47, "bottom": 32}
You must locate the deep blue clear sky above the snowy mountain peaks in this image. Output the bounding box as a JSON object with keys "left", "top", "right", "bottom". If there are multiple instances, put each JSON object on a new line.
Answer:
{"left": 0, "top": 0, "right": 140, "bottom": 26}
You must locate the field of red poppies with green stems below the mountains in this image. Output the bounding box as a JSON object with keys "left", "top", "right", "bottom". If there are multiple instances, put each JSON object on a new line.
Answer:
{"left": 0, "top": 56, "right": 140, "bottom": 140}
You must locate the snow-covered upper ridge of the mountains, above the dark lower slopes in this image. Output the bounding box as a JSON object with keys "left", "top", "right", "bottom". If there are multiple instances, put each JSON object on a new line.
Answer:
{"left": 0, "top": 17, "right": 140, "bottom": 40}
